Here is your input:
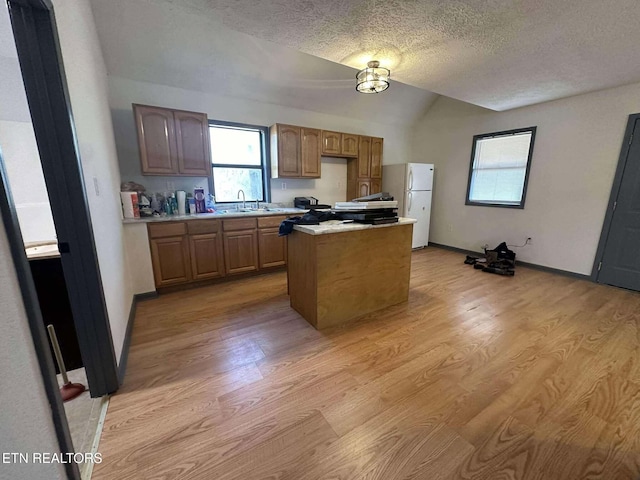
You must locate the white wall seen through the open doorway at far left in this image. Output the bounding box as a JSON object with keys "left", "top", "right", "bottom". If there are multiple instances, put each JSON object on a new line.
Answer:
{"left": 0, "top": 3, "right": 56, "bottom": 244}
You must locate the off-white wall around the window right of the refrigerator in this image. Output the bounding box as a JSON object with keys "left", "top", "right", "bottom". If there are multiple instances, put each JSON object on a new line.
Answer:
{"left": 413, "top": 84, "right": 640, "bottom": 274}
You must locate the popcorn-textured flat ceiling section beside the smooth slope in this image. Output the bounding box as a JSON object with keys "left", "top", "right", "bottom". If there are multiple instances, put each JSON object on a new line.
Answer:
{"left": 141, "top": 0, "right": 640, "bottom": 110}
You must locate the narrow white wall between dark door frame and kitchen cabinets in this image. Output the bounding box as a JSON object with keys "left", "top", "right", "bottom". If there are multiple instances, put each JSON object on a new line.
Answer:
{"left": 54, "top": 0, "right": 133, "bottom": 359}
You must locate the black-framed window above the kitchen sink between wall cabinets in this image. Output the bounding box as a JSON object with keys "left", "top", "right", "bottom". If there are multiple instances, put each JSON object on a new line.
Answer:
{"left": 209, "top": 120, "right": 269, "bottom": 203}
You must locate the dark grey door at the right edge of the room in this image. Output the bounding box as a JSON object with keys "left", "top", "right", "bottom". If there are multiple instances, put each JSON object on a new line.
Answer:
{"left": 598, "top": 118, "right": 640, "bottom": 291}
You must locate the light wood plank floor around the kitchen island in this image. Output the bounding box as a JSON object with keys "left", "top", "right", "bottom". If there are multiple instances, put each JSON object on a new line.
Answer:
{"left": 93, "top": 248, "right": 640, "bottom": 480}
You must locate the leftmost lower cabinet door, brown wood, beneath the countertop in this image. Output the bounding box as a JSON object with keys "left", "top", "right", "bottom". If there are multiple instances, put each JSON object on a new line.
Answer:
{"left": 151, "top": 235, "right": 191, "bottom": 287}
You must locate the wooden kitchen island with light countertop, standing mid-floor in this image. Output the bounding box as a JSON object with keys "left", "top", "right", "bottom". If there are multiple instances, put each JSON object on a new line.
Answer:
{"left": 288, "top": 218, "right": 416, "bottom": 330}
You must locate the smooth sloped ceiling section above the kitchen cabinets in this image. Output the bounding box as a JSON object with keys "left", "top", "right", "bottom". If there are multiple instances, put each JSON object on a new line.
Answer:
{"left": 92, "top": 0, "right": 438, "bottom": 124}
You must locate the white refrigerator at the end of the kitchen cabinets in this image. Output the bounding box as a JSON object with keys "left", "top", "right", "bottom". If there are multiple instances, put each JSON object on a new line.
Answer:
{"left": 382, "top": 163, "right": 433, "bottom": 248}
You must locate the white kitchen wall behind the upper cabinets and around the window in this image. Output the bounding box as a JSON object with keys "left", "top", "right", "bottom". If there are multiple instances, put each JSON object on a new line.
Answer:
{"left": 109, "top": 76, "right": 411, "bottom": 205}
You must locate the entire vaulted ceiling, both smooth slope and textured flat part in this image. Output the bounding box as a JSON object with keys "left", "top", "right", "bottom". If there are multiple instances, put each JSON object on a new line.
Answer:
{"left": 93, "top": 0, "right": 640, "bottom": 117}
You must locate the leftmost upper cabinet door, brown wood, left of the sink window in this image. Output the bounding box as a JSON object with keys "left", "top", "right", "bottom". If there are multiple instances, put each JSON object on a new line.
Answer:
{"left": 133, "top": 105, "right": 178, "bottom": 175}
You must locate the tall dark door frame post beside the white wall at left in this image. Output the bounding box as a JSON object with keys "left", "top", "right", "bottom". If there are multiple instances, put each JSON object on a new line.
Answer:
{"left": 7, "top": 0, "right": 119, "bottom": 397}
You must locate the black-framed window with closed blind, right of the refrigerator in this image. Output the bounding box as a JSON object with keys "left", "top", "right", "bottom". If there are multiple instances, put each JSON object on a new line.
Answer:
{"left": 466, "top": 127, "right": 536, "bottom": 208}
